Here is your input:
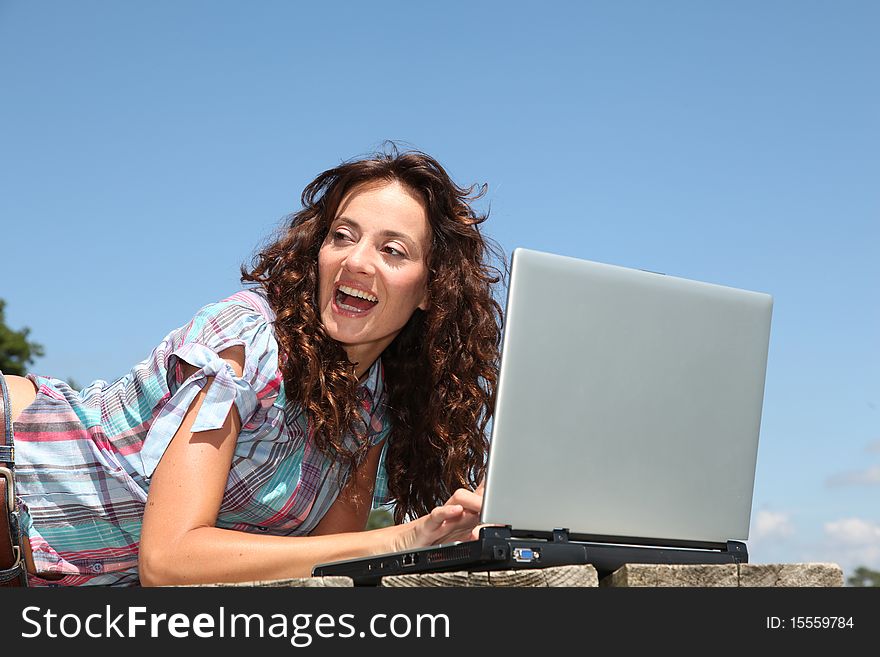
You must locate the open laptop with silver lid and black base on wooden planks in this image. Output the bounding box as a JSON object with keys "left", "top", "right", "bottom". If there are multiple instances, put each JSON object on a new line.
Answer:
{"left": 313, "top": 248, "right": 773, "bottom": 585}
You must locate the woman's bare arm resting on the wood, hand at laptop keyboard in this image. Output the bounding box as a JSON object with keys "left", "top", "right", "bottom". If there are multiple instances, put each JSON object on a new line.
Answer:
{"left": 139, "top": 347, "right": 482, "bottom": 586}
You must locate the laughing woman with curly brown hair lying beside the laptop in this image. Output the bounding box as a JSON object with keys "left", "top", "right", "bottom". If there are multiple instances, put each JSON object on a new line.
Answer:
{"left": 0, "top": 145, "right": 501, "bottom": 585}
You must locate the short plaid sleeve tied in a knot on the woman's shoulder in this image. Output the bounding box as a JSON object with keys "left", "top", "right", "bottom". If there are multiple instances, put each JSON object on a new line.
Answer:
{"left": 141, "top": 297, "right": 280, "bottom": 477}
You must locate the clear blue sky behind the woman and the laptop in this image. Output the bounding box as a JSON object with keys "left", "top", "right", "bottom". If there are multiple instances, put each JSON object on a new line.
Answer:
{"left": 0, "top": 0, "right": 880, "bottom": 572}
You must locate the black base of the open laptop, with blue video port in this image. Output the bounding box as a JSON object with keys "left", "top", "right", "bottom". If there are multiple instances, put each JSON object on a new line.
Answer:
{"left": 312, "top": 527, "right": 748, "bottom": 586}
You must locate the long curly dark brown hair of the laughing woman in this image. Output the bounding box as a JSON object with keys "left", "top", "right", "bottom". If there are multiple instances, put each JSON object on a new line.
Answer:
{"left": 241, "top": 144, "right": 507, "bottom": 522}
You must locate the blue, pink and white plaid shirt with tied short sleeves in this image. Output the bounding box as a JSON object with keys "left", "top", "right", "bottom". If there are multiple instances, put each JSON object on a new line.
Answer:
{"left": 15, "top": 291, "right": 390, "bottom": 586}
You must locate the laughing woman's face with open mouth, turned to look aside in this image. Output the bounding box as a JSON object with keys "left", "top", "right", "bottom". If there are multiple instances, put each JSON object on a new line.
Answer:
{"left": 318, "top": 181, "right": 431, "bottom": 376}
